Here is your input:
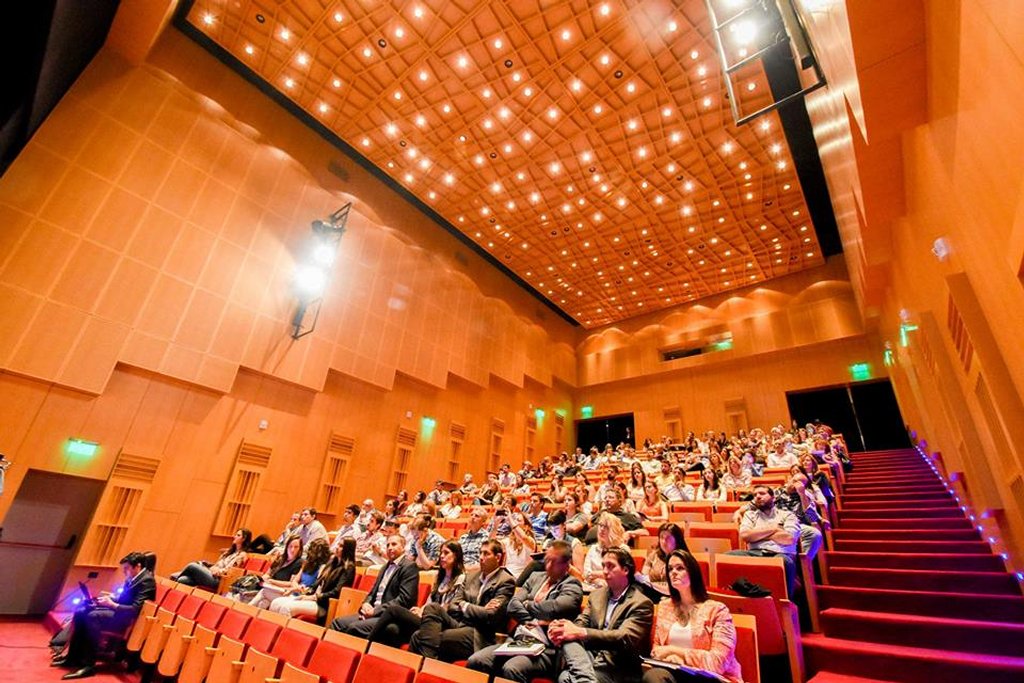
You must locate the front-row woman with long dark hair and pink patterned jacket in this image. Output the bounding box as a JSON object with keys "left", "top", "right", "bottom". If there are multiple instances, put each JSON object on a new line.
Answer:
{"left": 643, "top": 550, "right": 743, "bottom": 683}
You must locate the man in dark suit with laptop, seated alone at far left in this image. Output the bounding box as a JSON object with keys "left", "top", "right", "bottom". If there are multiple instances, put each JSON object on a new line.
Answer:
{"left": 52, "top": 553, "right": 157, "bottom": 681}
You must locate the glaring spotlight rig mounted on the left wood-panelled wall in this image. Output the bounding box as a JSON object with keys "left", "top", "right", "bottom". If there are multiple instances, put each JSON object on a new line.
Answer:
{"left": 292, "top": 202, "right": 352, "bottom": 339}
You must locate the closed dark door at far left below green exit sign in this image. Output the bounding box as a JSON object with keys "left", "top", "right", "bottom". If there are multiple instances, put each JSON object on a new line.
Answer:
{"left": 0, "top": 470, "right": 106, "bottom": 614}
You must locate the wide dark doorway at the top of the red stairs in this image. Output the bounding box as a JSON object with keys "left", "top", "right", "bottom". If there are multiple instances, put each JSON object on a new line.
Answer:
{"left": 785, "top": 380, "right": 910, "bottom": 453}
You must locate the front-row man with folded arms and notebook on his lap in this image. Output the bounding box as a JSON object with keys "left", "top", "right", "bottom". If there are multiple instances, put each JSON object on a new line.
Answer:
{"left": 468, "top": 541, "right": 583, "bottom": 683}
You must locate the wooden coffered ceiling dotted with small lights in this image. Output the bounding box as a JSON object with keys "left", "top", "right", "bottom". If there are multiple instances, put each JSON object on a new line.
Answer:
{"left": 183, "top": 0, "right": 824, "bottom": 328}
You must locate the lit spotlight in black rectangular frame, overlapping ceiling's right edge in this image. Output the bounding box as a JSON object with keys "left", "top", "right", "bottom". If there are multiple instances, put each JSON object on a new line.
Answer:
{"left": 705, "top": 0, "right": 825, "bottom": 126}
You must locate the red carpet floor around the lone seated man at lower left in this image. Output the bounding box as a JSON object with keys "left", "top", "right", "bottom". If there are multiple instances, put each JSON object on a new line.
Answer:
{"left": 0, "top": 620, "right": 138, "bottom": 683}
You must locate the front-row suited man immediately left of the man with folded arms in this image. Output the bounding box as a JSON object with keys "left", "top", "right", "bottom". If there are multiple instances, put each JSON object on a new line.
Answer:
{"left": 409, "top": 539, "right": 515, "bottom": 661}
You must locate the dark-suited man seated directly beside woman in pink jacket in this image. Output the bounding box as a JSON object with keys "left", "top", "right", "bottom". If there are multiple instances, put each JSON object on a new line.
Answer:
{"left": 548, "top": 548, "right": 654, "bottom": 683}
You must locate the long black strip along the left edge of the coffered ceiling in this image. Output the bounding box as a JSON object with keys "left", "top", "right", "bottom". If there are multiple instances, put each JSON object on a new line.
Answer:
{"left": 172, "top": 0, "right": 583, "bottom": 328}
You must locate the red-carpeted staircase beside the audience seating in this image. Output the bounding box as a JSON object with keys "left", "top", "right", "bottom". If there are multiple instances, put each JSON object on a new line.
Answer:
{"left": 803, "top": 450, "right": 1024, "bottom": 683}
